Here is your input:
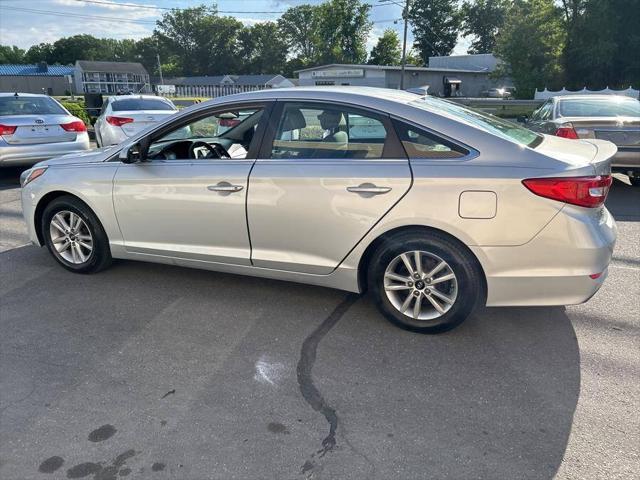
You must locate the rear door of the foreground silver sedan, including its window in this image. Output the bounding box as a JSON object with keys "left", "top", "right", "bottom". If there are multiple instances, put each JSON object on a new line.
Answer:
{"left": 247, "top": 102, "right": 411, "bottom": 274}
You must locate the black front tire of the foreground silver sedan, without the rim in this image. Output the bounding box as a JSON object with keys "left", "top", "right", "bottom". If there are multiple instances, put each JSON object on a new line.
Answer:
{"left": 40, "top": 195, "right": 113, "bottom": 273}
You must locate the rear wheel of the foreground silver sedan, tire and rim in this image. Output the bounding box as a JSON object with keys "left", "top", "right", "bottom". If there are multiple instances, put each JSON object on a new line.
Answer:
{"left": 368, "top": 232, "right": 484, "bottom": 334}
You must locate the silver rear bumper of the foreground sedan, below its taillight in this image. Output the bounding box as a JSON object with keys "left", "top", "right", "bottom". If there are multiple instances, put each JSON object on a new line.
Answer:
{"left": 471, "top": 205, "right": 617, "bottom": 307}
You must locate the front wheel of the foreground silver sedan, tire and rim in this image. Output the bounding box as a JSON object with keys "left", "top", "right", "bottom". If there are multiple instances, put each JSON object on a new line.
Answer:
{"left": 41, "top": 196, "right": 112, "bottom": 273}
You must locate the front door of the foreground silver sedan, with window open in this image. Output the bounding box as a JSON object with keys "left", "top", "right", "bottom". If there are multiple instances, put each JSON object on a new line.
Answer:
{"left": 113, "top": 104, "right": 268, "bottom": 265}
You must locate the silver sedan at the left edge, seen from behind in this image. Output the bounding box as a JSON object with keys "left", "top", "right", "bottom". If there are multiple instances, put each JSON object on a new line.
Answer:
{"left": 0, "top": 93, "right": 89, "bottom": 167}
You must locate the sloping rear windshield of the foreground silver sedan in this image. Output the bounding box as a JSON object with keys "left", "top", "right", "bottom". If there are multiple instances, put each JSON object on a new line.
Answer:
{"left": 410, "top": 97, "right": 543, "bottom": 147}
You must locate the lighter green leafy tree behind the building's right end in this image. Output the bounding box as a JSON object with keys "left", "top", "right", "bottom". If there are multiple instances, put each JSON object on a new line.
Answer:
{"left": 495, "top": 0, "right": 566, "bottom": 98}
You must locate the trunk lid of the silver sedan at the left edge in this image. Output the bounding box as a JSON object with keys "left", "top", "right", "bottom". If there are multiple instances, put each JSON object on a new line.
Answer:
{"left": 0, "top": 115, "right": 78, "bottom": 145}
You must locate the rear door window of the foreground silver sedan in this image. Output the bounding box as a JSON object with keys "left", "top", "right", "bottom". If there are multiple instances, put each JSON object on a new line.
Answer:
{"left": 271, "top": 103, "right": 387, "bottom": 159}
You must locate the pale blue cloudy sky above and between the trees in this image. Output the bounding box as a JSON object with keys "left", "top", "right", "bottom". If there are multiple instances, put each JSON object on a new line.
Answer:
{"left": 0, "top": 0, "right": 469, "bottom": 54}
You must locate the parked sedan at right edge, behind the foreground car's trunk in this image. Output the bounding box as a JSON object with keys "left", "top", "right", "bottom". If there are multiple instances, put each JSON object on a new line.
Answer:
{"left": 522, "top": 95, "right": 640, "bottom": 186}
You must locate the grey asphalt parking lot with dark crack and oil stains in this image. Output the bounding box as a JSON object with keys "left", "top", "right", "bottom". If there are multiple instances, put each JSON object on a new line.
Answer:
{"left": 0, "top": 172, "right": 640, "bottom": 480}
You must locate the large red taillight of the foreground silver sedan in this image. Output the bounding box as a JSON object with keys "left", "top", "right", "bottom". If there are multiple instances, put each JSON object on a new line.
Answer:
{"left": 522, "top": 175, "right": 613, "bottom": 208}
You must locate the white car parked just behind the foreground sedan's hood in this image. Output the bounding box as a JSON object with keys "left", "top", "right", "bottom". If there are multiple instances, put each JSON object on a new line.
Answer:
{"left": 95, "top": 95, "right": 178, "bottom": 147}
